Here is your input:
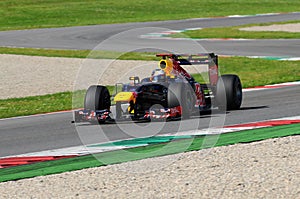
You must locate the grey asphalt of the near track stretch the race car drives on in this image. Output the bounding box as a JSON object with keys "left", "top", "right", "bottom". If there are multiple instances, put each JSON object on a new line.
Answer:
{"left": 0, "top": 85, "right": 300, "bottom": 157}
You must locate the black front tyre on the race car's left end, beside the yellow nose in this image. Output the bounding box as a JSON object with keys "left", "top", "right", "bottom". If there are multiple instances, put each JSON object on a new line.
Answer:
{"left": 84, "top": 85, "right": 111, "bottom": 110}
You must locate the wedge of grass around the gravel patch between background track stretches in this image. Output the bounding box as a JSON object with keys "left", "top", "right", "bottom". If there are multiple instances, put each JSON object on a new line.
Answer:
{"left": 171, "top": 20, "right": 300, "bottom": 39}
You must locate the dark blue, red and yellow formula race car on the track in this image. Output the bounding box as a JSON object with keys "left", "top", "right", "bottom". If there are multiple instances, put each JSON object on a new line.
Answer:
{"left": 75, "top": 53, "right": 242, "bottom": 123}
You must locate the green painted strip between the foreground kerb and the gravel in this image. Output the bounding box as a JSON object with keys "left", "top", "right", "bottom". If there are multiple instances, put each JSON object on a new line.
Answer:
{"left": 0, "top": 124, "right": 300, "bottom": 182}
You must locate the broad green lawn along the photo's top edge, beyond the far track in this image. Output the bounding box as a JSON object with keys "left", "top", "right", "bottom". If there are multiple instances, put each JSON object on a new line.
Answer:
{"left": 0, "top": 0, "right": 300, "bottom": 30}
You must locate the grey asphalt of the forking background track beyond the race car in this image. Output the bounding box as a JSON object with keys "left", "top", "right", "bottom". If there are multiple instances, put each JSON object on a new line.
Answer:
{"left": 0, "top": 13, "right": 300, "bottom": 56}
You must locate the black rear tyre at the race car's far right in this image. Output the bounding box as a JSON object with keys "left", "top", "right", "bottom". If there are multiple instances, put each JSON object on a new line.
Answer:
{"left": 217, "top": 75, "right": 243, "bottom": 110}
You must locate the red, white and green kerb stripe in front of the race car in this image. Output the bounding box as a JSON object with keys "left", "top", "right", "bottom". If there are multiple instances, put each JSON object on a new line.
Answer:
{"left": 0, "top": 116, "right": 300, "bottom": 169}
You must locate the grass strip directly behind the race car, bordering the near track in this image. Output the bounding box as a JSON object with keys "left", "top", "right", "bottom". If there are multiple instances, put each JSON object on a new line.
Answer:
{"left": 0, "top": 57, "right": 300, "bottom": 118}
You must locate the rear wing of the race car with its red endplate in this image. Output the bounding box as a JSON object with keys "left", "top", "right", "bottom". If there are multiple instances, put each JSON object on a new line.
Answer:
{"left": 156, "top": 53, "right": 219, "bottom": 86}
